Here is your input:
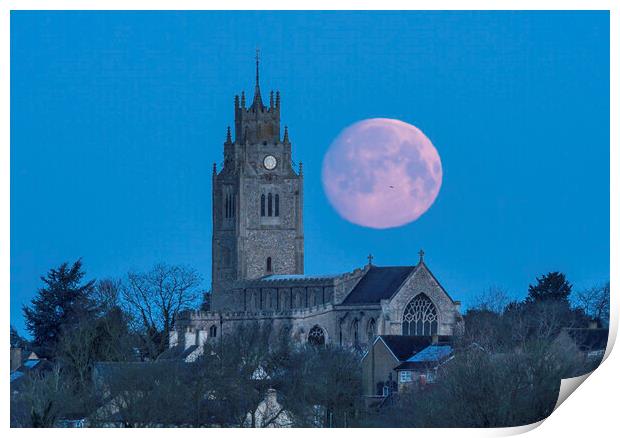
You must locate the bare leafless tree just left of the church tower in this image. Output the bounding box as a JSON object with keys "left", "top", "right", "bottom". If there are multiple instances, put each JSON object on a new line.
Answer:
{"left": 121, "top": 264, "right": 201, "bottom": 358}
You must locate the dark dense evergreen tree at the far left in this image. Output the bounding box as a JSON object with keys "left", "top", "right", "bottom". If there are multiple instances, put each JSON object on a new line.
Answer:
{"left": 22, "top": 260, "right": 95, "bottom": 354}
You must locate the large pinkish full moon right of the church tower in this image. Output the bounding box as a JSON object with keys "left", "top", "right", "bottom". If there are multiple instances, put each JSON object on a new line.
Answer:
{"left": 322, "top": 119, "right": 442, "bottom": 229}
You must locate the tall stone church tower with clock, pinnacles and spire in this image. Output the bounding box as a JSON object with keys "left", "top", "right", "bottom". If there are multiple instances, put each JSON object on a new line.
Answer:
{"left": 212, "top": 55, "right": 304, "bottom": 309}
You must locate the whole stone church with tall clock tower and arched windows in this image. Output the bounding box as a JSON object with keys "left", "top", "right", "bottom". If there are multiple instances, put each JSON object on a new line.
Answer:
{"left": 169, "top": 57, "right": 463, "bottom": 350}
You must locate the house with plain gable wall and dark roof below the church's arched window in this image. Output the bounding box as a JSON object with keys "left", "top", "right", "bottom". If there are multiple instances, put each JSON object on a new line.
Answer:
{"left": 362, "top": 335, "right": 452, "bottom": 399}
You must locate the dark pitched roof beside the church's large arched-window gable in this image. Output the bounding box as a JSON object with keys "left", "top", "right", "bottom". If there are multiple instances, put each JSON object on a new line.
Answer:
{"left": 342, "top": 266, "right": 415, "bottom": 306}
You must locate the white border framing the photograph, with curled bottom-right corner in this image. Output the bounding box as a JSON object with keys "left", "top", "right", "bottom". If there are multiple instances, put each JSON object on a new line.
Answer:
{"left": 0, "top": 0, "right": 620, "bottom": 437}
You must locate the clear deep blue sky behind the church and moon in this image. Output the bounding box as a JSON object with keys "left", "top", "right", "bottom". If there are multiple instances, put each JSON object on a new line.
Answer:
{"left": 11, "top": 12, "right": 609, "bottom": 331}
